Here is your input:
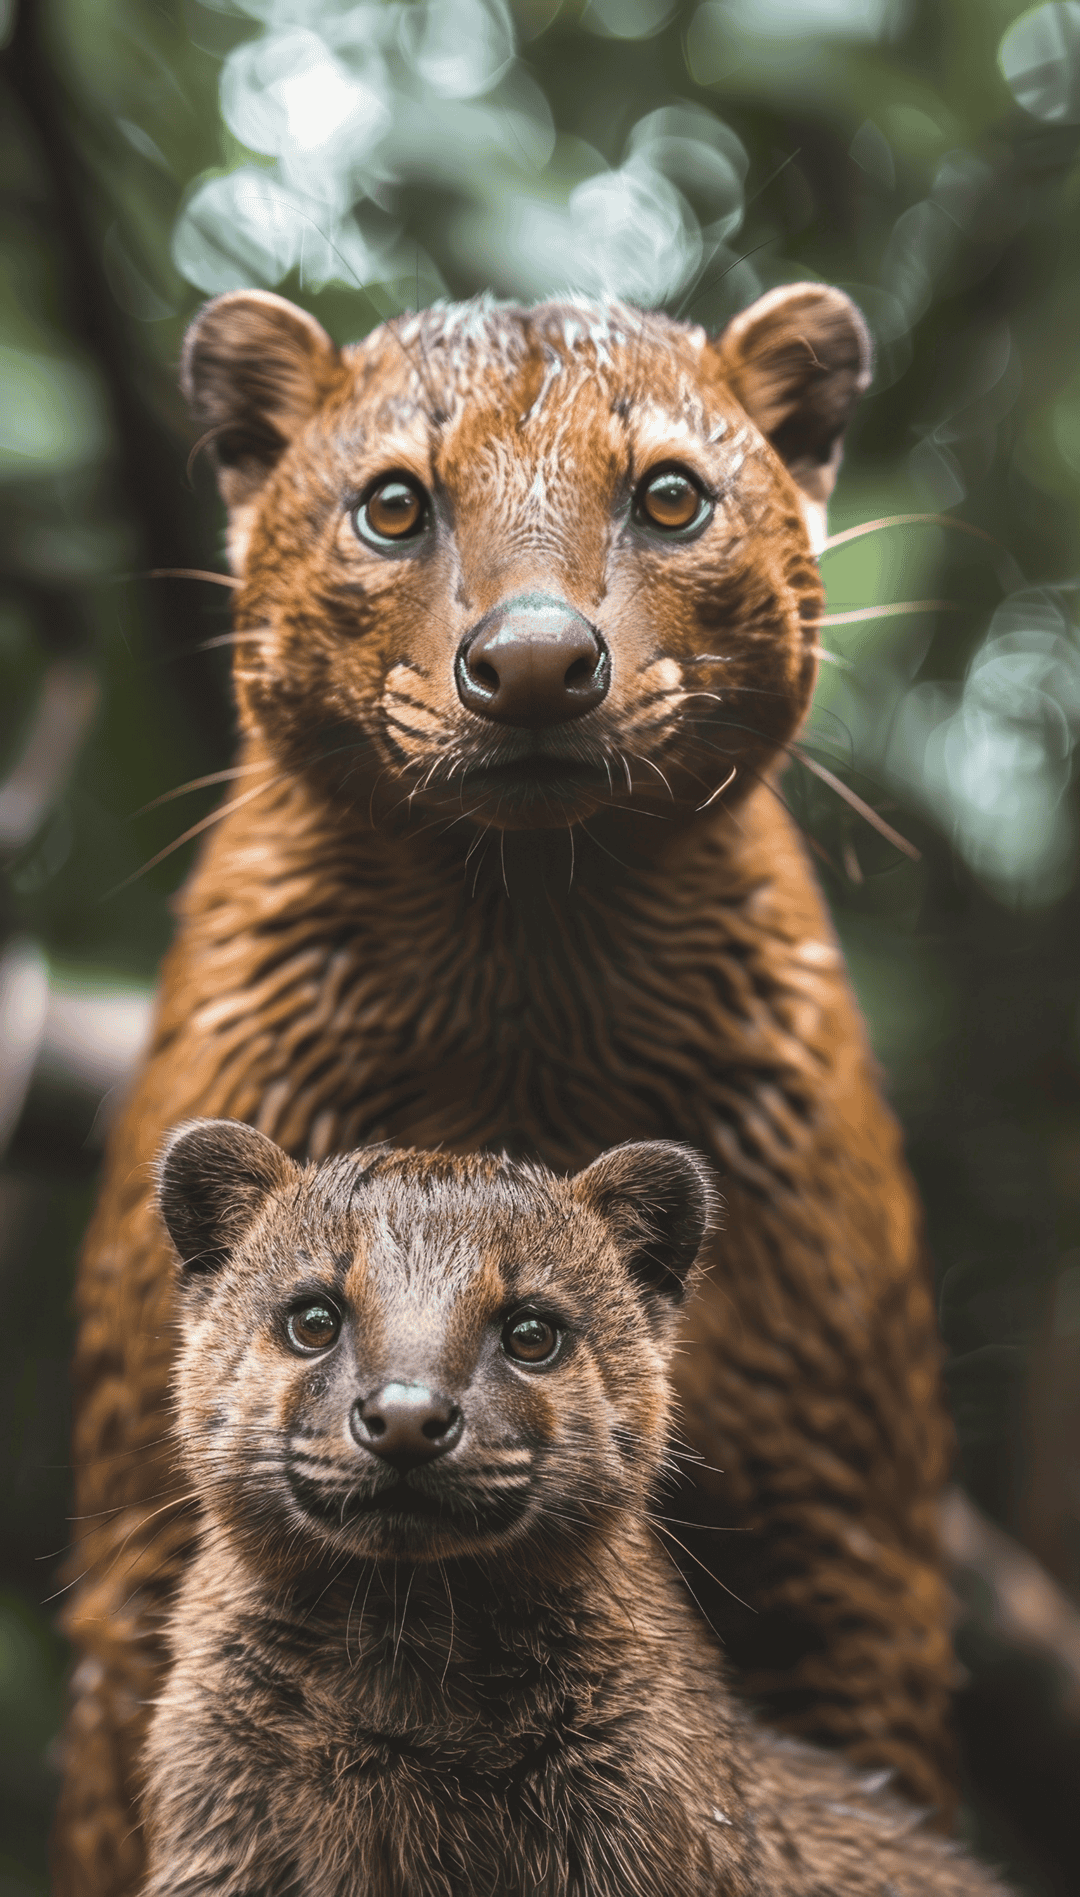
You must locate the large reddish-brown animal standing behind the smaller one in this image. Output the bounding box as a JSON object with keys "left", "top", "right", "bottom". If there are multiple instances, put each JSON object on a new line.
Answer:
{"left": 55, "top": 285, "right": 953, "bottom": 1897}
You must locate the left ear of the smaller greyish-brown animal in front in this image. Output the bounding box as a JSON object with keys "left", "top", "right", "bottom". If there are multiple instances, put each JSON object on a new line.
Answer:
{"left": 158, "top": 1119, "right": 300, "bottom": 1277}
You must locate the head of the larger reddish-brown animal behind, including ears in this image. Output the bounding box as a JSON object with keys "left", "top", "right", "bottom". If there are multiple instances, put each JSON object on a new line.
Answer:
{"left": 184, "top": 283, "right": 869, "bottom": 827}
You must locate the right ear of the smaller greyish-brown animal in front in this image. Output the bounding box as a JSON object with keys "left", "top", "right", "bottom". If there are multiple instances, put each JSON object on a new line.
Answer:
{"left": 573, "top": 1140, "right": 716, "bottom": 1303}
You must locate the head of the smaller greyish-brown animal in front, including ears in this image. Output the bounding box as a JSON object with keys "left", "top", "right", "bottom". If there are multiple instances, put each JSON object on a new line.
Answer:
{"left": 159, "top": 1121, "right": 710, "bottom": 1573}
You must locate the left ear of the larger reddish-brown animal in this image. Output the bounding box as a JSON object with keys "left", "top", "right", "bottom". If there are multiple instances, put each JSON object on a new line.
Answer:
{"left": 180, "top": 290, "right": 340, "bottom": 508}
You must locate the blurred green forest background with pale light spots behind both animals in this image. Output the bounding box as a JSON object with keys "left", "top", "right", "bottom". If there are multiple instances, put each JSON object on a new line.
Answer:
{"left": 0, "top": 0, "right": 1080, "bottom": 1897}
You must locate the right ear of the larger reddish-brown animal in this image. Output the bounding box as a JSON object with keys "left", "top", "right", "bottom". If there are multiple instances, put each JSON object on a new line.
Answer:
{"left": 714, "top": 283, "right": 873, "bottom": 542}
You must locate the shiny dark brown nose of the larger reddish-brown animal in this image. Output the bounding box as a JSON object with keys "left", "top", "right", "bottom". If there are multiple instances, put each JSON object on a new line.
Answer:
{"left": 456, "top": 594, "right": 611, "bottom": 727}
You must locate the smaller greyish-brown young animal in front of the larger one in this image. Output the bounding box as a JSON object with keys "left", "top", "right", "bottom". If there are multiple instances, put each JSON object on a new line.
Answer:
{"left": 138, "top": 1121, "right": 998, "bottom": 1897}
